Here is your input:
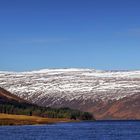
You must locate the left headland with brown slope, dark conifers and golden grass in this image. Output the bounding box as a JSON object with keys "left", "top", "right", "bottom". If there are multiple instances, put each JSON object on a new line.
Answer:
{"left": 0, "top": 88, "right": 94, "bottom": 125}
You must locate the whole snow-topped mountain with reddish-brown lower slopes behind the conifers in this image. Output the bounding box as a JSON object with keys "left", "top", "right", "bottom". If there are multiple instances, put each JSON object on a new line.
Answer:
{"left": 0, "top": 69, "right": 140, "bottom": 119}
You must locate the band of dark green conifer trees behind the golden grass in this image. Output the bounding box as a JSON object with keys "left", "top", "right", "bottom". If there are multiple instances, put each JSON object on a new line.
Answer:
{"left": 0, "top": 100, "right": 94, "bottom": 120}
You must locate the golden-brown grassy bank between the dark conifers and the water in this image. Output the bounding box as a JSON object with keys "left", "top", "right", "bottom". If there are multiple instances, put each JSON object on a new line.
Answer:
{"left": 0, "top": 114, "right": 72, "bottom": 125}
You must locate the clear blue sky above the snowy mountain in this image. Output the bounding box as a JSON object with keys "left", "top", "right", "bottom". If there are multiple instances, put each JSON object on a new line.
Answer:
{"left": 0, "top": 0, "right": 140, "bottom": 71}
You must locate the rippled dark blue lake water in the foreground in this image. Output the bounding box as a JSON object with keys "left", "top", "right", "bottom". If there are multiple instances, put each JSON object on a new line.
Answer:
{"left": 0, "top": 121, "right": 140, "bottom": 140}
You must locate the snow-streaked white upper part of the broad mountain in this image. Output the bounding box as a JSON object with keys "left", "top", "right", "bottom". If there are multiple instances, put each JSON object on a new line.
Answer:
{"left": 0, "top": 68, "right": 140, "bottom": 105}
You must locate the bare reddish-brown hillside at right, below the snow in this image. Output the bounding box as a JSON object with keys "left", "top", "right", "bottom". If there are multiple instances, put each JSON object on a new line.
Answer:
{"left": 88, "top": 94, "right": 140, "bottom": 120}
